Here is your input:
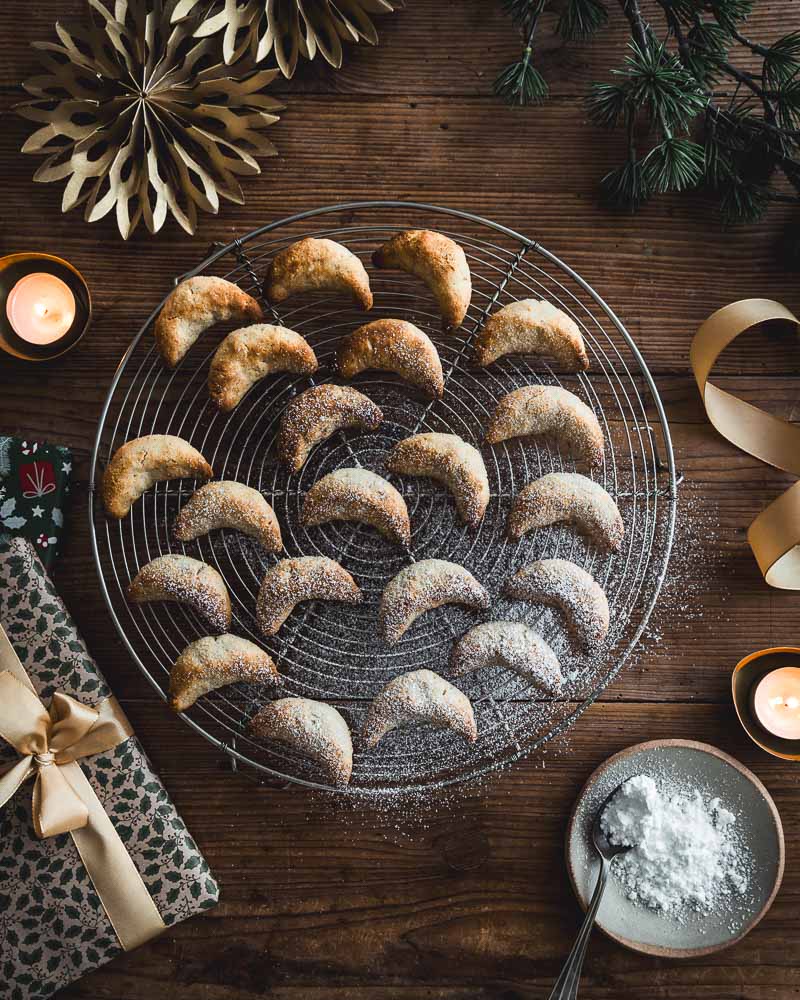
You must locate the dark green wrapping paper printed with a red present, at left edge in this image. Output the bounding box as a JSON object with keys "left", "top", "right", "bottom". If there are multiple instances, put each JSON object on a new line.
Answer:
{"left": 0, "top": 437, "right": 72, "bottom": 569}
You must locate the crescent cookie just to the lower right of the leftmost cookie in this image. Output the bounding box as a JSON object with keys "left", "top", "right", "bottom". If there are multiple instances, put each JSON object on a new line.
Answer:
{"left": 175, "top": 480, "right": 283, "bottom": 552}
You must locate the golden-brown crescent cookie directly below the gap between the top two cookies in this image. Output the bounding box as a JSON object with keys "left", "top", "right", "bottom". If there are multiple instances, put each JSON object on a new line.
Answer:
{"left": 337, "top": 319, "right": 444, "bottom": 399}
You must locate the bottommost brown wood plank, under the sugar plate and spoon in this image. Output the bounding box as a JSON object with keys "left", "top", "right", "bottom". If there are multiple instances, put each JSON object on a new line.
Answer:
{"left": 54, "top": 704, "right": 800, "bottom": 1000}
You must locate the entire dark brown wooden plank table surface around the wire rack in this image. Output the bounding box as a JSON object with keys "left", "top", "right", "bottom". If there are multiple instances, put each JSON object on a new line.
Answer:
{"left": 0, "top": 0, "right": 800, "bottom": 1000}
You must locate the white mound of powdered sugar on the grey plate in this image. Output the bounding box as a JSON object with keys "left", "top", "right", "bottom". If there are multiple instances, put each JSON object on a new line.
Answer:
{"left": 600, "top": 774, "right": 748, "bottom": 919}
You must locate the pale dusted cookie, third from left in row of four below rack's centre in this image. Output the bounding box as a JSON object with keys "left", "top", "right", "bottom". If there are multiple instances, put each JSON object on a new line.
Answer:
{"left": 378, "top": 559, "right": 490, "bottom": 644}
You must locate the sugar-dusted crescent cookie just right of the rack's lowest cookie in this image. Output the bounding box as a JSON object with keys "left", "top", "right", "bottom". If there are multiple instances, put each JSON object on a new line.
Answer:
{"left": 362, "top": 670, "right": 478, "bottom": 747}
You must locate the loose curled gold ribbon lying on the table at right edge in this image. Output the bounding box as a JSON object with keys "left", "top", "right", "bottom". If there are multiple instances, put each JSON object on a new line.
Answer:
{"left": 689, "top": 299, "right": 800, "bottom": 590}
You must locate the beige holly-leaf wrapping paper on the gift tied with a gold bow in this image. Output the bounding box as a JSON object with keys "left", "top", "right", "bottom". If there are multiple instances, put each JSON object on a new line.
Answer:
{"left": 0, "top": 538, "right": 219, "bottom": 1000}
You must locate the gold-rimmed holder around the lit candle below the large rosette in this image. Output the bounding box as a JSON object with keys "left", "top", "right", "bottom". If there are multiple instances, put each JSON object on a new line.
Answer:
{"left": 0, "top": 253, "right": 92, "bottom": 361}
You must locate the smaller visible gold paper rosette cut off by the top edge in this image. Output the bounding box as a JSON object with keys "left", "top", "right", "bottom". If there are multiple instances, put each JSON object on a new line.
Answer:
{"left": 173, "top": 0, "right": 405, "bottom": 77}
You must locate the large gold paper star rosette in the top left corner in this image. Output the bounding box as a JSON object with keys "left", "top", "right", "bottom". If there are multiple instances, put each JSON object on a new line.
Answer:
{"left": 17, "top": 0, "right": 283, "bottom": 239}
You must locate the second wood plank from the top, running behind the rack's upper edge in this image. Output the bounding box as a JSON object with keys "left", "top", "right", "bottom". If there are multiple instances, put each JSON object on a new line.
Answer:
{"left": 0, "top": 97, "right": 800, "bottom": 382}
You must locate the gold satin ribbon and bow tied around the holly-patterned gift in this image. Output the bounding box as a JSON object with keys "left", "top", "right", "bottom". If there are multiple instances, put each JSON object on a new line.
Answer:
{"left": 0, "top": 625, "right": 165, "bottom": 951}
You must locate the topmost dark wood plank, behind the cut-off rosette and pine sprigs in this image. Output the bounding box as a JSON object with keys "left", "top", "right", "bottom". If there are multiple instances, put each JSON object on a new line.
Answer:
{"left": 0, "top": 0, "right": 796, "bottom": 97}
